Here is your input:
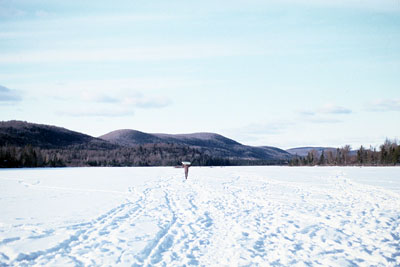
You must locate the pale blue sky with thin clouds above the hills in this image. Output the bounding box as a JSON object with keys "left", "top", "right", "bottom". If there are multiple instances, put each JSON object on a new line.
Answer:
{"left": 0, "top": 0, "right": 400, "bottom": 149}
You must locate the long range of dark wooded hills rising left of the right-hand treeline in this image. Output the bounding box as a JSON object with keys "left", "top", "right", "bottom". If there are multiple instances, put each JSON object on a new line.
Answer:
{"left": 0, "top": 121, "right": 292, "bottom": 167}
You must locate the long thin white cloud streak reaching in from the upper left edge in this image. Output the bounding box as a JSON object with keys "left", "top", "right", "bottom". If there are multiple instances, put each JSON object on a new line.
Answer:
{"left": 0, "top": 43, "right": 265, "bottom": 64}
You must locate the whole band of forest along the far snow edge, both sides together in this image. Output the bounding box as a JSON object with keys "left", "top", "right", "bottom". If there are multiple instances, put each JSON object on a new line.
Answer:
{"left": 0, "top": 140, "right": 400, "bottom": 168}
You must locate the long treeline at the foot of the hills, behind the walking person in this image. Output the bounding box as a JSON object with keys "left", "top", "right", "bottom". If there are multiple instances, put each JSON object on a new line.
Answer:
{"left": 0, "top": 144, "right": 264, "bottom": 168}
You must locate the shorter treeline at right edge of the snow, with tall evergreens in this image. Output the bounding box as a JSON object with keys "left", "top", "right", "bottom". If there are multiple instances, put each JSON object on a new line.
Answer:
{"left": 289, "top": 139, "right": 400, "bottom": 166}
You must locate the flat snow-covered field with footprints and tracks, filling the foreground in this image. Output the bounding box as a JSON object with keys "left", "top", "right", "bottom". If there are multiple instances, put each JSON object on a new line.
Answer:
{"left": 0, "top": 167, "right": 400, "bottom": 266}
